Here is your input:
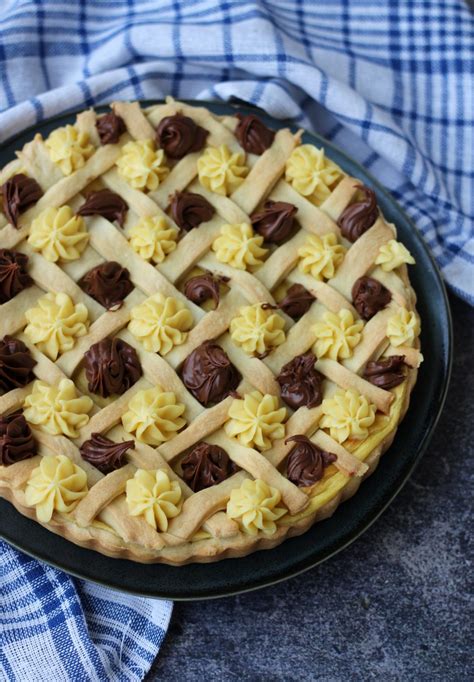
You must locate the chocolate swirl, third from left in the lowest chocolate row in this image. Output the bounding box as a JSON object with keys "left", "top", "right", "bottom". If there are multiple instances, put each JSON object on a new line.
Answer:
{"left": 181, "top": 443, "right": 237, "bottom": 493}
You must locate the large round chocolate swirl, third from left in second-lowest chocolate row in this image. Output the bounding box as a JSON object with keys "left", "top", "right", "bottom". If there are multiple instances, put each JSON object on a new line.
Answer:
{"left": 181, "top": 341, "right": 242, "bottom": 406}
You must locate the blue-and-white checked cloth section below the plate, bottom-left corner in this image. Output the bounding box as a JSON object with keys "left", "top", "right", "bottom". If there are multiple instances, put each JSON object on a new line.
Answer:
{"left": 0, "top": 540, "right": 172, "bottom": 682}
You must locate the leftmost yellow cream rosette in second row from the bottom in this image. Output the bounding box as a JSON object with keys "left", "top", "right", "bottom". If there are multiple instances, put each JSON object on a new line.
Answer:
{"left": 23, "top": 379, "right": 93, "bottom": 438}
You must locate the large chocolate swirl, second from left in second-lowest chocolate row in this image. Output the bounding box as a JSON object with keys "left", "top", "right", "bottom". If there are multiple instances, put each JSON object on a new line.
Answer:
{"left": 84, "top": 338, "right": 142, "bottom": 398}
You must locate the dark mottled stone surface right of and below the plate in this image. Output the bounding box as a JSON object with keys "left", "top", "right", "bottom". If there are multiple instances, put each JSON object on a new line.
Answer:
{"left": 149, "top": 298, "right": 474, "bottom": 682}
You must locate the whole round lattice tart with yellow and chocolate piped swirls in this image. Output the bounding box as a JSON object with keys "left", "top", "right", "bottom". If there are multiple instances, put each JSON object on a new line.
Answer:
{"left": 0, "top": 99, "right": 422, "bottom": 565}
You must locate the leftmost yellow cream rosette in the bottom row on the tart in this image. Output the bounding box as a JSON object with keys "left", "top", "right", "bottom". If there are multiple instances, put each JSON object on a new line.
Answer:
{"left": 25, "top": 455, "right": 88, "bottom": 523}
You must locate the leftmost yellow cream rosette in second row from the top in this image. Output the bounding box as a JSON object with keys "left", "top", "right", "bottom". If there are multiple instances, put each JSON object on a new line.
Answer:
{"left": 28, "top": 206, "right": 89, "bottom": 263}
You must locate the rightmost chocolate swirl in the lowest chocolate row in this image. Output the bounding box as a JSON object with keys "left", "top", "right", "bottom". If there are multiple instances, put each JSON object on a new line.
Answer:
{"left": 285, "top": 435, "right": 337, "bottom": 487}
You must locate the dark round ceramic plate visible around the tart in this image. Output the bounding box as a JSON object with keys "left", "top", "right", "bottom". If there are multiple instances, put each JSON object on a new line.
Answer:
{"left": 0, "top": 102, "right": 452, "bottom": 599}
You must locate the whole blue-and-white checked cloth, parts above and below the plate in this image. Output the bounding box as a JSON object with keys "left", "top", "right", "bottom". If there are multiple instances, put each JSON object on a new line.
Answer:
{"left": 0, "top": 0, "right": 474, "bottom": 680}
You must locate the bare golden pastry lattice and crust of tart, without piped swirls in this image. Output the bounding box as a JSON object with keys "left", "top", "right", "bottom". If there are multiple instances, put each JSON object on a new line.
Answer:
{"left": 0, "top": 95, "right": 421, "bottom": 565}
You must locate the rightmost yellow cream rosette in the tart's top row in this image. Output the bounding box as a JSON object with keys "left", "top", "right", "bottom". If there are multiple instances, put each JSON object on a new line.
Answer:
{"left": 285, "top": 144, "right": 342, "bottom": 206}
